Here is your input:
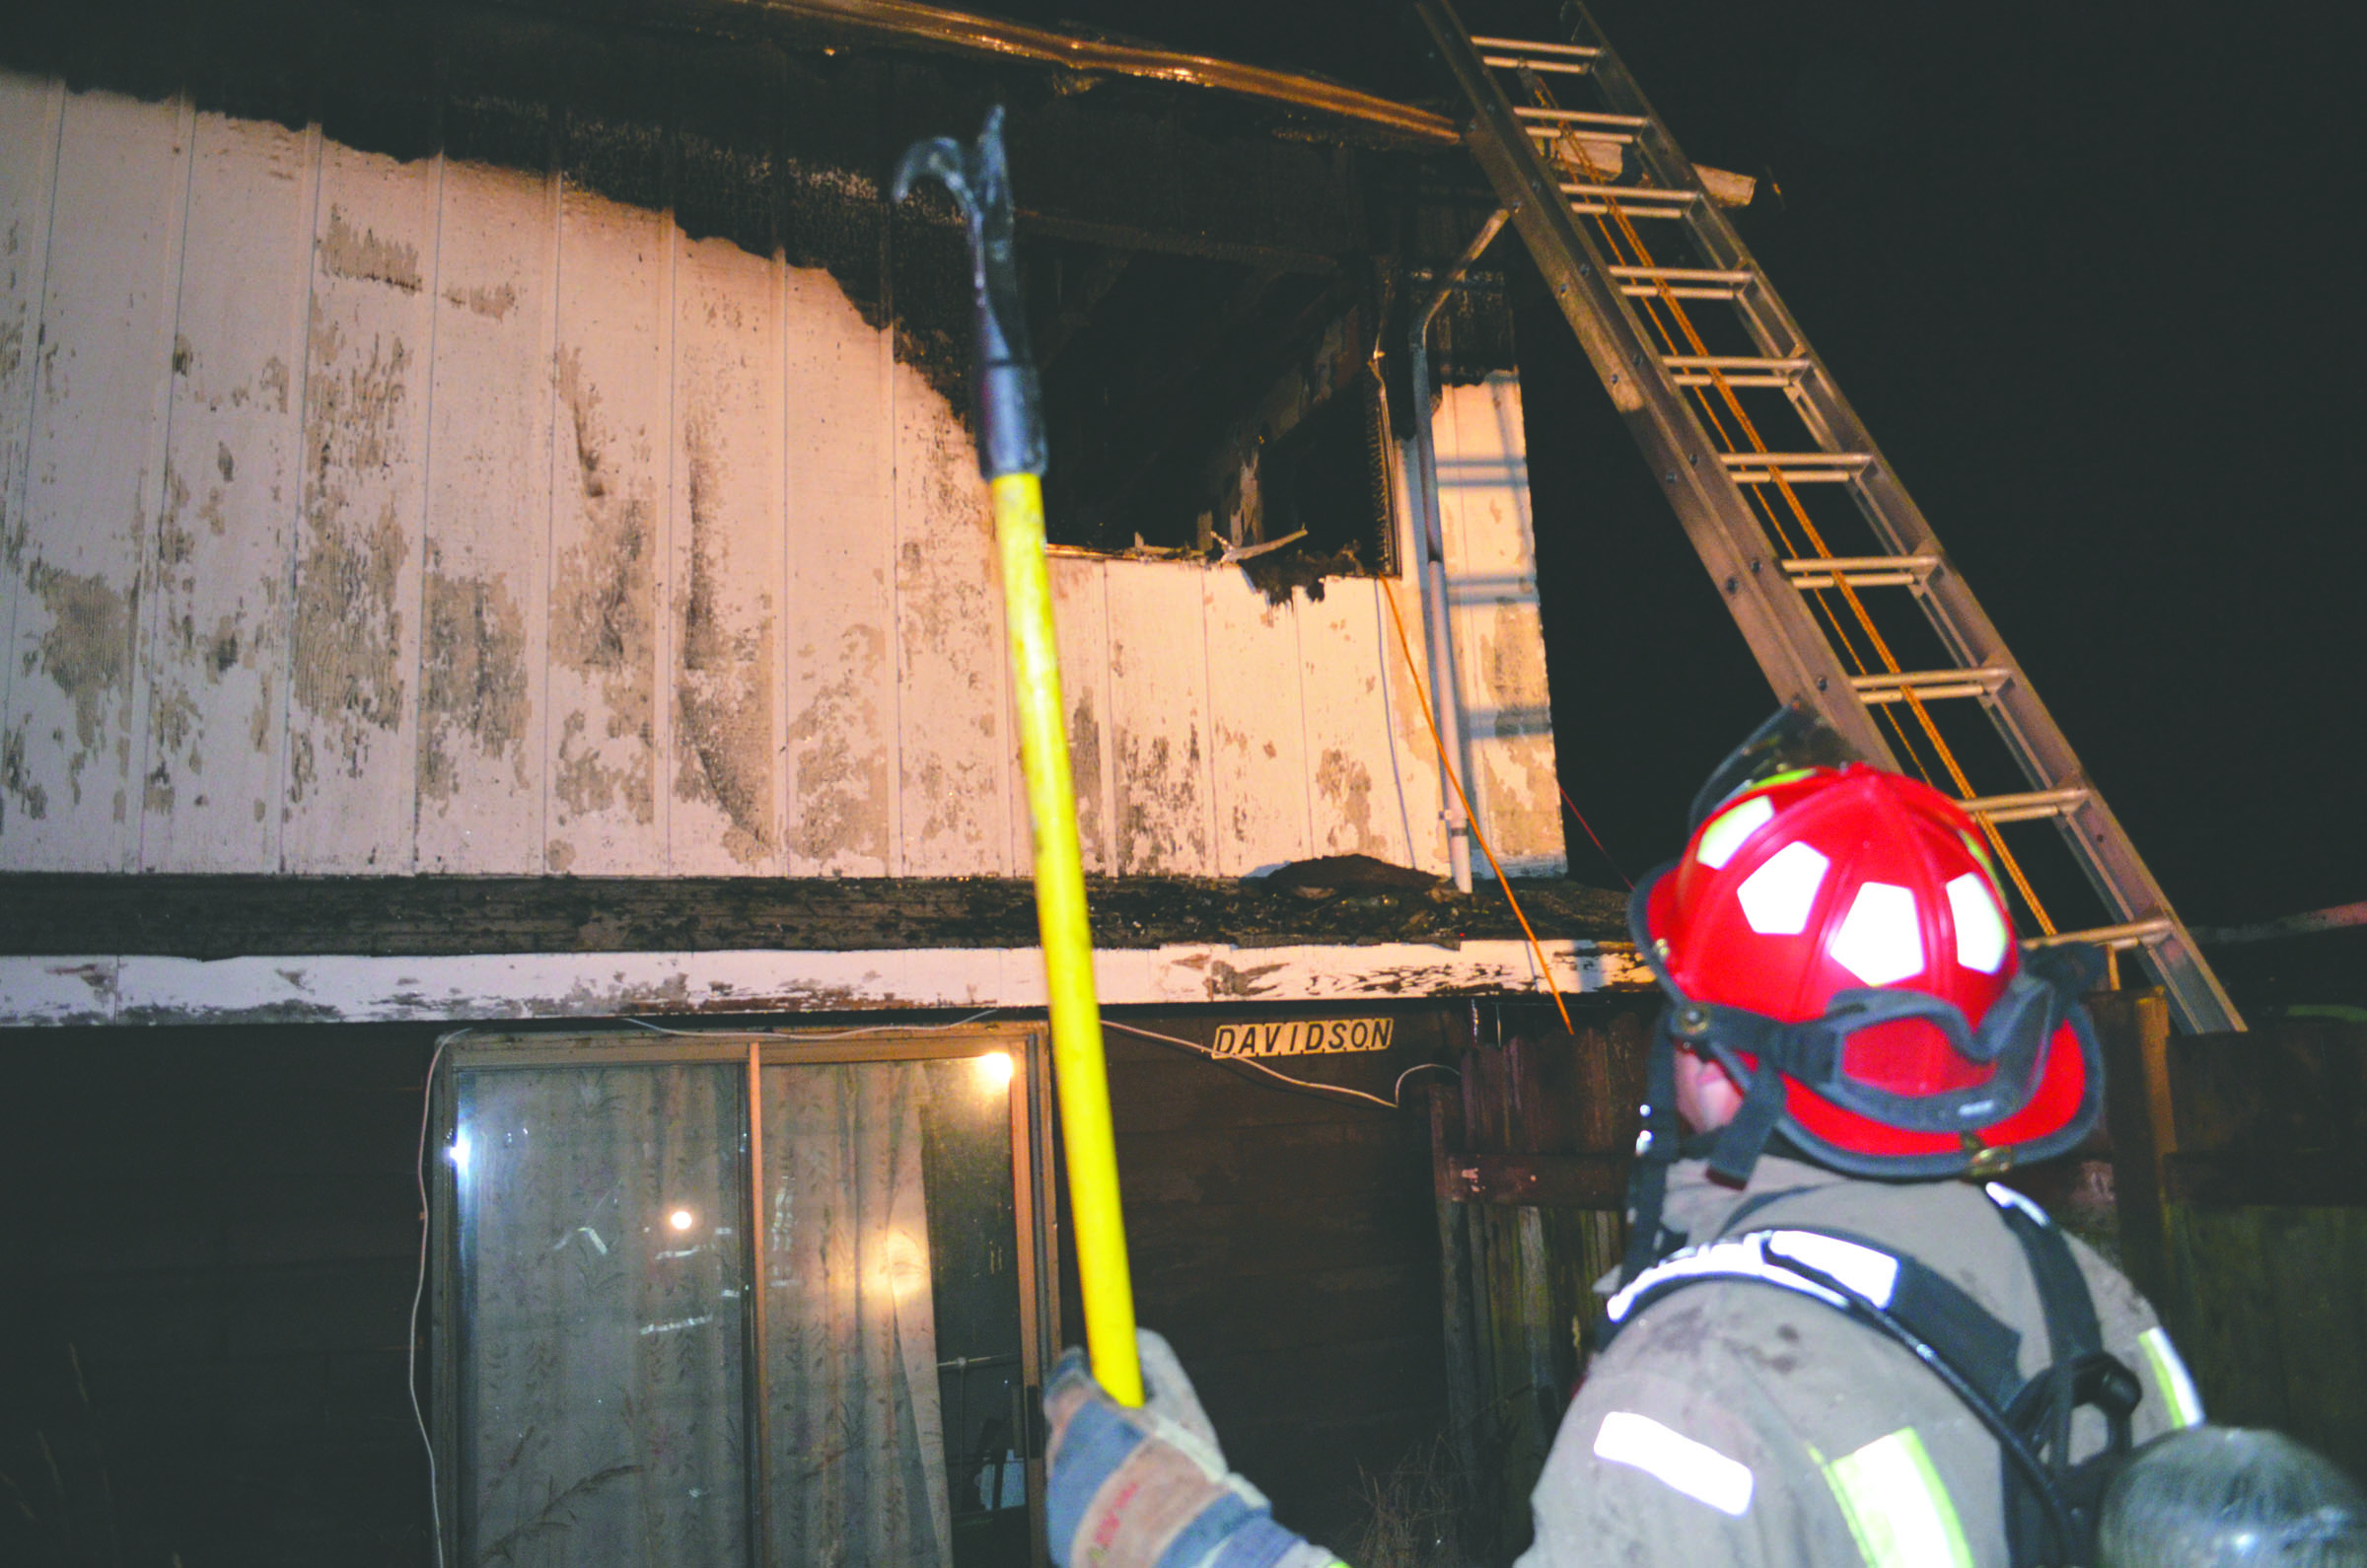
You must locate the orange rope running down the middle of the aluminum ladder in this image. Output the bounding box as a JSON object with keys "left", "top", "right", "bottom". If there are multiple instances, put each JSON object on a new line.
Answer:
{"left": 1520, "top": 77, "right": 2057, "bottom": 936}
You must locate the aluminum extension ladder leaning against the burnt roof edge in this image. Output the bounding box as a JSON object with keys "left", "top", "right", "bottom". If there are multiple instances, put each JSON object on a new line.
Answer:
{"left": 1415, "top": 0, "right": 2244, "bottom": 1033}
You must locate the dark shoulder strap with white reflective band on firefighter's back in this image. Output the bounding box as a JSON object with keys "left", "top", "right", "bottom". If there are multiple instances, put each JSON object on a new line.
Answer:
{"left": 1603, "top": 1184, "right": 2140, "bottom": 1568}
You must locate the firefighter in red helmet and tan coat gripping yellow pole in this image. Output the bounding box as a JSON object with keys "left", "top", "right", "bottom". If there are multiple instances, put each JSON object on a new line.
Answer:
{"left": 1046, "top": 708, "right": 2201, "bottom": 1568}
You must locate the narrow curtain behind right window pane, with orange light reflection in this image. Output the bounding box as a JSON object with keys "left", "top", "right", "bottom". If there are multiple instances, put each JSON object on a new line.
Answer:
{"left": 759, "top": 1061, "right": 954, "bottom": 1568}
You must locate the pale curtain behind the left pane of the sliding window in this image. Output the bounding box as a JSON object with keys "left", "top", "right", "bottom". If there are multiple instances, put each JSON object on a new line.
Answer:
{"left": 455, "top": 1063, "right": 751, "bottom": 1568}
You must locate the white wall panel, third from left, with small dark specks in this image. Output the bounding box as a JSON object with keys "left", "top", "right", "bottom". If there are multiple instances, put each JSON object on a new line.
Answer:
{"left": 140, "top": 113, "right": 320, "bottom": 872}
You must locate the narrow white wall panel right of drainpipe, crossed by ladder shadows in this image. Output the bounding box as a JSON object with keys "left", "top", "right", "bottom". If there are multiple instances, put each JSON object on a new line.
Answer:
{"left": 1434, "top": 374, "right": 1567, "bottom": 872}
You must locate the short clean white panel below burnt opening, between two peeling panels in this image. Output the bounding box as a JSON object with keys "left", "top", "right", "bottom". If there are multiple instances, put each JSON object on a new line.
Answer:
{"left": 1200, "top": 566, "right": 1309, "bottom": 877}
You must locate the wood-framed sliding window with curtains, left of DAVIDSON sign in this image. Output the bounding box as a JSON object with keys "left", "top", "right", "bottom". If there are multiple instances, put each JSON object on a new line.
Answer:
{"left": 438, "top": 1028, "right": 1053, "bottom": 1568}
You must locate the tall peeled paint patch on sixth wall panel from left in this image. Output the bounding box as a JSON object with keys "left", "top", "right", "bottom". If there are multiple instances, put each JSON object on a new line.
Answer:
{"left": 551, "top": 348, "right": 658, "bottom": 824}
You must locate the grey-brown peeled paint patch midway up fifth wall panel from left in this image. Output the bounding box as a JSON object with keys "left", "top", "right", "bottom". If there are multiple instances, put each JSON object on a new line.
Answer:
{"left": 419, "top": 571, "right": 533, "bottom": 801}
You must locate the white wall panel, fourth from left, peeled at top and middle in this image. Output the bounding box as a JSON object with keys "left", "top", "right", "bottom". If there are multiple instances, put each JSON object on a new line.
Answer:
{"left": 279, "top": 142, "right": 440, "bottom": 872}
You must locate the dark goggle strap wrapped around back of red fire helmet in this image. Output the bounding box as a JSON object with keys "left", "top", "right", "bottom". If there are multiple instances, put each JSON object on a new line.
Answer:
{"left": 1628, "top": 867, "right": 2102, "bottom": 1184}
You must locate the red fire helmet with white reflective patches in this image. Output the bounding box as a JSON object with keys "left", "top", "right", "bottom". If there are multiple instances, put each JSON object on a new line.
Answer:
{"left": 1633, "top": 762, "right": 2102, "bottom": 1175}
